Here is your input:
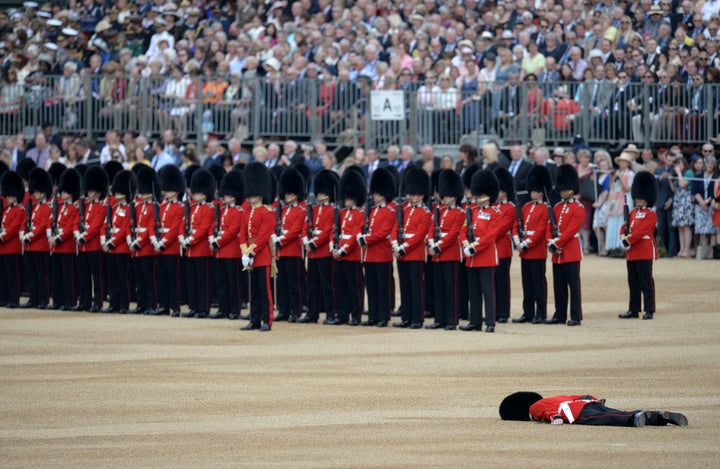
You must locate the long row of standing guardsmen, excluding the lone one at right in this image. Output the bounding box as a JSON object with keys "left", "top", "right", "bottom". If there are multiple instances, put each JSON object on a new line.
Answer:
{"left": 0, "top": 153, "right": 660, "bottom": 332}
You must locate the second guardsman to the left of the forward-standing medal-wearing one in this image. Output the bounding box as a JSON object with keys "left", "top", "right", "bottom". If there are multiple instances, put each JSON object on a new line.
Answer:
{"left": 392, "top": 166, "right": 432, "bottom": 329}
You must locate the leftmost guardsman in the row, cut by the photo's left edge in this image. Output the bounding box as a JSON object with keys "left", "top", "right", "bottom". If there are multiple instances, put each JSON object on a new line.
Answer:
{"left": 0, "top": 171, "right": 26, "bottom": 308}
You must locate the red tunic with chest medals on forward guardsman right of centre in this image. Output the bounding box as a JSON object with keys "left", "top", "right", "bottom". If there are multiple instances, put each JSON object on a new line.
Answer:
{"left": 460, "top": 205, "right": 502, "bottom": 268}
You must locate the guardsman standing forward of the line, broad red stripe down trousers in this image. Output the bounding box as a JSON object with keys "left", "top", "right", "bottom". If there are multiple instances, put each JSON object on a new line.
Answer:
{"left": 240, "top": 162, "right": 275, "bottom": 331}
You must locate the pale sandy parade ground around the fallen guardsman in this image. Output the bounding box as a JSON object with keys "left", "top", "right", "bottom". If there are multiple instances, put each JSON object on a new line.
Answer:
{"left": 0, "top": 256, "right": 720, "bottom": 468}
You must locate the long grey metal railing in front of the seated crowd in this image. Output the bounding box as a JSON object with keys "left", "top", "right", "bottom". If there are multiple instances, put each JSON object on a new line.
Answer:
{"left": 0, "top": 74, "right": 720, "bottom": 150}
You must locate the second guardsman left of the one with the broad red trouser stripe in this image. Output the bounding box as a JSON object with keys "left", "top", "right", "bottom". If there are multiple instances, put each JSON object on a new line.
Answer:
{"left": 179, "top": 169, "right": 216, "bottom": 318}
